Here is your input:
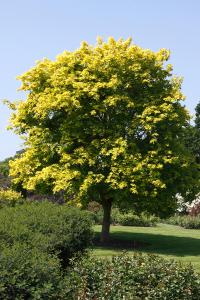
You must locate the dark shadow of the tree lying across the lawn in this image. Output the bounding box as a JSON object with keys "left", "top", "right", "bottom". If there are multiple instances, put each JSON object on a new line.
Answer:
{"left": 93, "top": 231, "right": 200, "bottom": 256}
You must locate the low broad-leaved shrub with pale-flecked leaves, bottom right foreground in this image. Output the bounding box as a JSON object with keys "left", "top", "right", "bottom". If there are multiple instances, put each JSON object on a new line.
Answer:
{"left": 70, "top": 254, "right": 200, "bottom": 300}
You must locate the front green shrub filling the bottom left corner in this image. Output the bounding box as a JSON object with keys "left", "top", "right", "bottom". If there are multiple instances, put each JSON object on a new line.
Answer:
{"left": 0, "top": 243, "right": 71, "bottom": 300}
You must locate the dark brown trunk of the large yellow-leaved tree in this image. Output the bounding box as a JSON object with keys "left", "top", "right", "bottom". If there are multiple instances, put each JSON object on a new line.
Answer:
{"left": 101, "top": 199, "right": 112, "bottom": 243}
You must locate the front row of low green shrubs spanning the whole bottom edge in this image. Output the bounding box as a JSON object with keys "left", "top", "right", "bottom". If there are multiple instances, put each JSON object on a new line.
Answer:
{"left": 0, "top": 250, "right": 200, "bottom": 300}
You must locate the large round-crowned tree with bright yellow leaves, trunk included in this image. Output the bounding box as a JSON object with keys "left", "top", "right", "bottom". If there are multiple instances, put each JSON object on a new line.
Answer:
{"left": 7, "top": 38, "right": 198, "bottom": 241}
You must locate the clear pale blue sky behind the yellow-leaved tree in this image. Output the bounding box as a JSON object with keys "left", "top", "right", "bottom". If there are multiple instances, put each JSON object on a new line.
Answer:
{"left": 0, "top": 0, "right": 200, "bottom": 160}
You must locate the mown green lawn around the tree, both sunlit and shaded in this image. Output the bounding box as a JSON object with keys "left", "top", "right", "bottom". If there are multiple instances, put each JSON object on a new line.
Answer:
{"left": 93, "top": 224, "right": 200, "bottom": 272}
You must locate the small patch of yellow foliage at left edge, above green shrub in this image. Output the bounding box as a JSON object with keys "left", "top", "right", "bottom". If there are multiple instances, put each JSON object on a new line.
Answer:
{"left": 0, "top": 188, "right": 22, "bottom": 207}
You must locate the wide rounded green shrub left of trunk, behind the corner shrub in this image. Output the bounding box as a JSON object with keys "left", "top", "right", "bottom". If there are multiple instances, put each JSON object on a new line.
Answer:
{"left": 0, "top": 202, "right": 93, "bottom": 262}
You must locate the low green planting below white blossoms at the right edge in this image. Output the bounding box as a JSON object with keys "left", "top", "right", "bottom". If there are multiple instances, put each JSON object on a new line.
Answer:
{"left": 165, "top": 215, "right": 200, "bottom": 229}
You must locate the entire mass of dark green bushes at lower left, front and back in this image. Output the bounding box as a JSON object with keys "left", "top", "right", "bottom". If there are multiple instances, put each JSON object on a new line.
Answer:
{"left": 0, "top": 202, "right": 93, "bottom": 300}
